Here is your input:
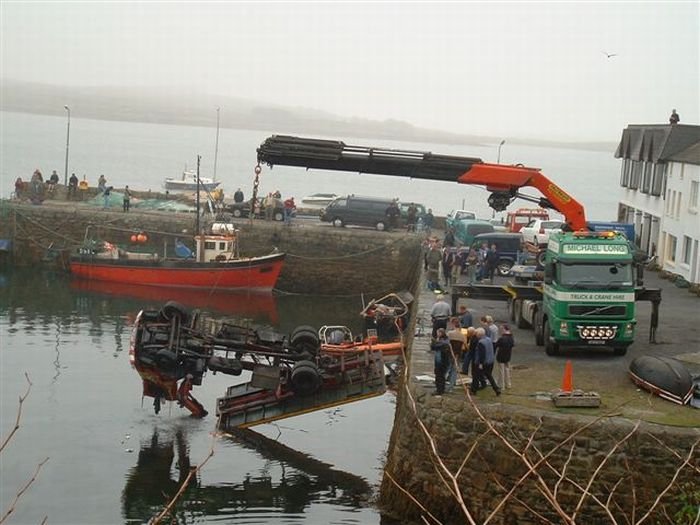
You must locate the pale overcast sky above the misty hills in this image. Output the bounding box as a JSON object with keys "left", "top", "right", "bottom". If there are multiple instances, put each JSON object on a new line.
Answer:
{"left": 0, "top": 0, "right": 700, "bottom": 141}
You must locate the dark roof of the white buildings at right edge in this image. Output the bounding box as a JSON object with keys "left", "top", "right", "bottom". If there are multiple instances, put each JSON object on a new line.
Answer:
{"left": 615, "top": 124, "right": 700, "bottom": 164}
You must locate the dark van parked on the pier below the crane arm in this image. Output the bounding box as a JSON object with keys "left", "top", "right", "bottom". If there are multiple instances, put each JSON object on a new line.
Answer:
{"left": 320, "top": 195, "right": 393, "bottom": 231}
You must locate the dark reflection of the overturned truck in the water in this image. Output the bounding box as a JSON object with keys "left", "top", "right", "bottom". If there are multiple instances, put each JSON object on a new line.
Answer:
{"left": 122, "top": 428, "right": 372, "bottom": 523}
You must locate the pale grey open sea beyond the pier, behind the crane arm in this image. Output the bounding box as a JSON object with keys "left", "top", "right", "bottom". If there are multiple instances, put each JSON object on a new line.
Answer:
{"left": 0, "top": 108, "right": 622, "bottom": 220}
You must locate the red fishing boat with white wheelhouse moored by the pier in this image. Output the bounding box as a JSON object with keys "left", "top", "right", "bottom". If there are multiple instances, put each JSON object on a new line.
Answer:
{"left": 69, "top": 223, "right": 285, "bottom": 292}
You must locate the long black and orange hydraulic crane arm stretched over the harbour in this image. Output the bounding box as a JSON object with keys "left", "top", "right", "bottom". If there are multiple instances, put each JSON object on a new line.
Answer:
{"left": 258, "top": 135, "right": 587, "bottom": 231}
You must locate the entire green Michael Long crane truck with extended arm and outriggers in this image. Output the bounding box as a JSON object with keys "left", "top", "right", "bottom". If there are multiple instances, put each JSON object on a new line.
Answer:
{"left": 258, "top": 135, "right": 661, "bottom": 355}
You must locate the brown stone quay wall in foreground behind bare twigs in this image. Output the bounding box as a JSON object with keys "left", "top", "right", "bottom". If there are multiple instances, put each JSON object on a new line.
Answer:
{"left": 380, "top": 372, "right": 700, "bottom": 525}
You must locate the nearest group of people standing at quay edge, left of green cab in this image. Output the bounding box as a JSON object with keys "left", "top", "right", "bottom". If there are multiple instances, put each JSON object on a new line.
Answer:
{"left": 430, "top": 295, "right": 515, "bottom": 396}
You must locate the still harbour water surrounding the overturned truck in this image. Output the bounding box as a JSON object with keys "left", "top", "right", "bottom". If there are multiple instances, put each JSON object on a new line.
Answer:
{"left": 0, "top": 271, "right": 394, "bottom": 524}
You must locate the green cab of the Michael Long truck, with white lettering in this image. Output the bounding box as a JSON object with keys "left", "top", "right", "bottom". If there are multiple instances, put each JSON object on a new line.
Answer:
{"left": 534, "top": 231, "right": 636, "bottom": 355}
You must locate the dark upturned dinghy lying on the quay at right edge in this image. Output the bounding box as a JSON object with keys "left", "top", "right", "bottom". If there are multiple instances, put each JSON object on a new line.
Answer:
{"left": 629, "top": 355, "right": 694, "bottom": 405}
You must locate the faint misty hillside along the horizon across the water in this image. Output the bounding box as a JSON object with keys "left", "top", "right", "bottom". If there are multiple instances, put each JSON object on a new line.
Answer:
{"left": 0, "top": 79, "right": 615, "bottom": 151}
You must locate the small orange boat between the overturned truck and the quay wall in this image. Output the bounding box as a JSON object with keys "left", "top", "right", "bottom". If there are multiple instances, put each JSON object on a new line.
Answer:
{"left": 318, "top": 292, "right": 413, "bottom": 363}
